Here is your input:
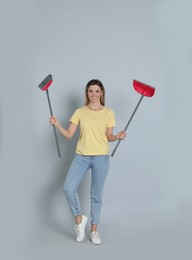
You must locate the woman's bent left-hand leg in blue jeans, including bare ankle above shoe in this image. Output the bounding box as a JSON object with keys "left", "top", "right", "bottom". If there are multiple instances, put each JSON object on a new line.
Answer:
{"left": 63, "top": 154, "right": 90, "bottom": 221}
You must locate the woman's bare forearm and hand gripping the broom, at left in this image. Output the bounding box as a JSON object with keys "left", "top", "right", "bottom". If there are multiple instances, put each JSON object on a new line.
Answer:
{"left": 50, "top": 116, "right": 78, "bottom": 139}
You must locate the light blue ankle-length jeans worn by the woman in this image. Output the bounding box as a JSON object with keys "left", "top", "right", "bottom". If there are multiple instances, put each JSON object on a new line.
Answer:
{"left": 63, "top": 154, "right": 109, "bottom": 224}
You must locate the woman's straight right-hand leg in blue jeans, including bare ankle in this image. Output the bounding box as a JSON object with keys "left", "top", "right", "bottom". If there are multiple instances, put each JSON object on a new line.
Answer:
{"left": 91, "top": 155, "right": 109, "bottom": 232}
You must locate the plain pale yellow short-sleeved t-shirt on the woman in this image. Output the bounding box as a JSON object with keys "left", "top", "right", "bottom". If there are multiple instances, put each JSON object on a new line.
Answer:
{"left": 69, "top": 106, "right": 116, "bottom": 155}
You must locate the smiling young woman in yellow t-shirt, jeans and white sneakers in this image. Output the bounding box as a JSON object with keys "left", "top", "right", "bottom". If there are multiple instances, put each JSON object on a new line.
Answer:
{"left": 50, "top": 79, "right": 126, "bottom": 245}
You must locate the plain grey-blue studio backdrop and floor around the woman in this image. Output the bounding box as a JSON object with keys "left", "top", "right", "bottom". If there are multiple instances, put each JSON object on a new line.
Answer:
{"left": 0, "top": 0, "right": 192, "bottom": 260}
